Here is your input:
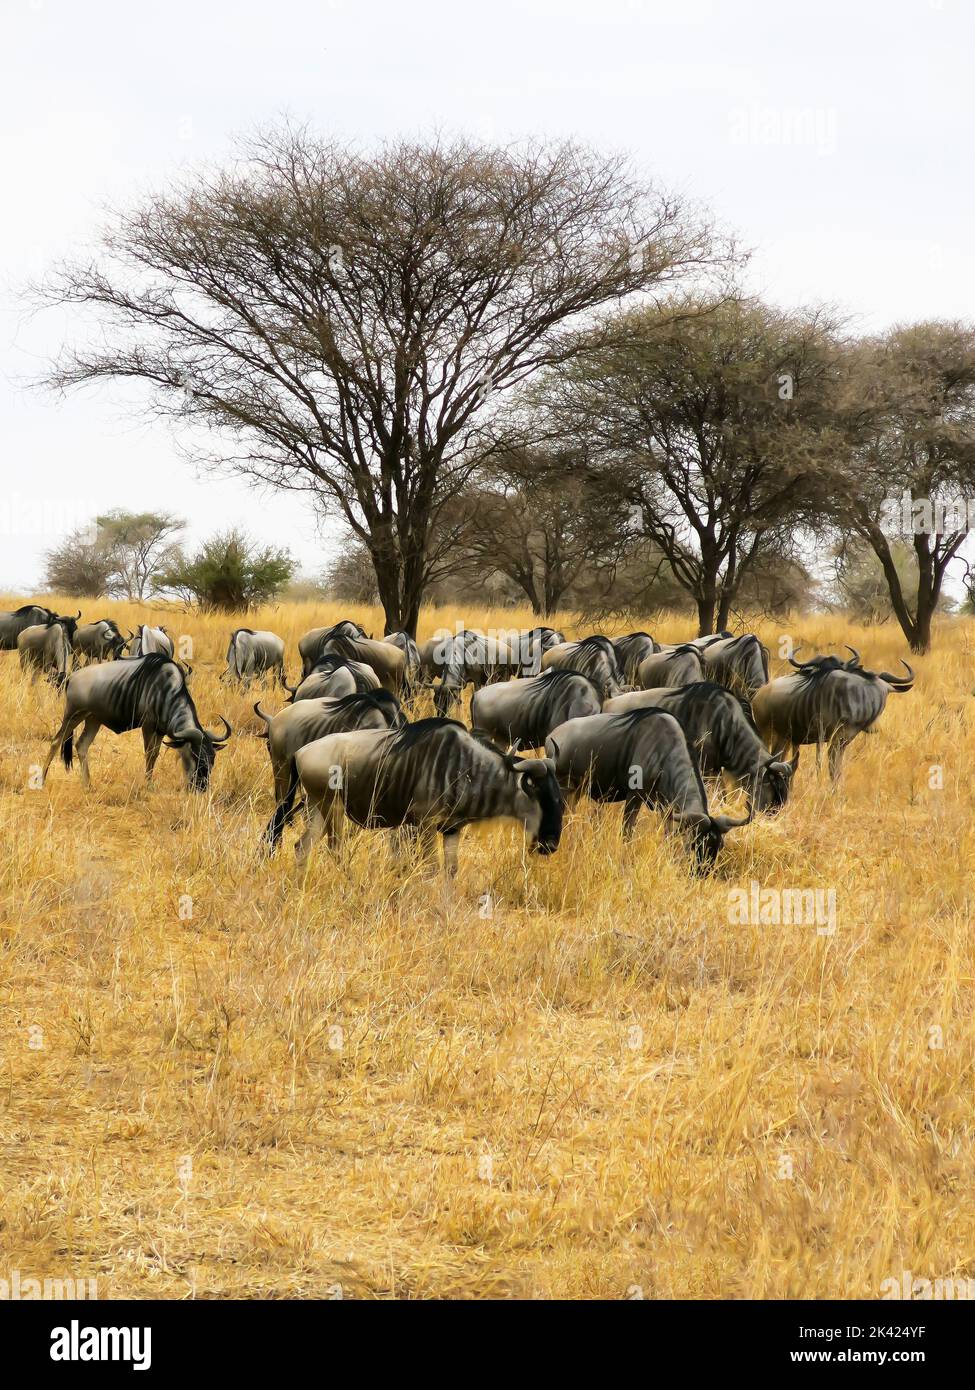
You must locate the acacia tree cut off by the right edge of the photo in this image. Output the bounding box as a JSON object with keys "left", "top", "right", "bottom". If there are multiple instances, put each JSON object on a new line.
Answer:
{"left": 830, "top": 322, "right": 975, "bottom": 652}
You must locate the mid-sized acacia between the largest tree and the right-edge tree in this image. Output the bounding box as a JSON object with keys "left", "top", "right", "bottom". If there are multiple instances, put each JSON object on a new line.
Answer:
{"left": 533, "top": 297, "right": 836, "bottom": 634}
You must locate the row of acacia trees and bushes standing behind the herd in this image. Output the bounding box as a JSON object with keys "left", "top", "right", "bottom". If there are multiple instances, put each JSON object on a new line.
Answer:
{"left": 42, "top": 128, "right": 975, "bottom": 651}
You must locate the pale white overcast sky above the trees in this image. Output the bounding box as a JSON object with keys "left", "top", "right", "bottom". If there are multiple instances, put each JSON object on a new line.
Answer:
{"left": 0, "top": 0, "right": 975, "bottom": 592}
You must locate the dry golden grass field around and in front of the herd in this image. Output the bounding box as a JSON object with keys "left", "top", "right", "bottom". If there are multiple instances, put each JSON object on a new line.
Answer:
{"left": 0, "top": 599, "right": 975, "bottom": 1298}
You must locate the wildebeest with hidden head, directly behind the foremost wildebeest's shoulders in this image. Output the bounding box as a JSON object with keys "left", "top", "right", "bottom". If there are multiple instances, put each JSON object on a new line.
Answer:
{"left": 470, "top": 667, "right": 601, "bottom": 748}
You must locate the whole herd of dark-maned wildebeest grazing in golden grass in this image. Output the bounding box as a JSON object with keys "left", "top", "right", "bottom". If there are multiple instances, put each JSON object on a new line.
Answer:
{"left": 0, "top": 605, "right": 914, "bottom": 876}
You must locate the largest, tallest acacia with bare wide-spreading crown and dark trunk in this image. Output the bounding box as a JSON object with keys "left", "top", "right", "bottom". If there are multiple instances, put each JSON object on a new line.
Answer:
{"left": 46, "top": 128, "right": 715, "bottom": 632}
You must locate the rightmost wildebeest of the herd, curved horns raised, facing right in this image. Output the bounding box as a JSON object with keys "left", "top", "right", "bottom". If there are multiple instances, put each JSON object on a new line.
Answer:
{"left": 751, "top": 646, "right": 914, "bottom": 781}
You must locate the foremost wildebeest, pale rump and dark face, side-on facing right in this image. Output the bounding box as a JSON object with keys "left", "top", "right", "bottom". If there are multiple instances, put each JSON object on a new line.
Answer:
{"left": 296, "top": 717, "right": 562, "bottom": 877}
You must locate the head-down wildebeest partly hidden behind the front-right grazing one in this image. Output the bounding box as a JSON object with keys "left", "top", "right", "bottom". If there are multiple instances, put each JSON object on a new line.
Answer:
{"left": 602, "top": 681, "right": 796, "bottom": 810}
